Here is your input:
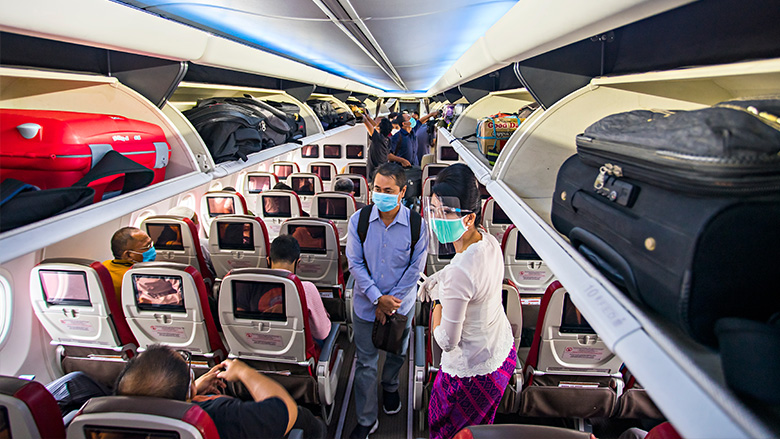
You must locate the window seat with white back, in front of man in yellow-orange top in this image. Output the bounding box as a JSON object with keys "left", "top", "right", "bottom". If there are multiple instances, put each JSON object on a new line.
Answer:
{"left": 30, "top": 258, "right": 138, "bottom": 388}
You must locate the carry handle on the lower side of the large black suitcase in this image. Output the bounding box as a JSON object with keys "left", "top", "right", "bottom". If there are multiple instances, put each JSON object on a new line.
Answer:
{"left": 569, "top": 227, "right": 642, "bottom": 302}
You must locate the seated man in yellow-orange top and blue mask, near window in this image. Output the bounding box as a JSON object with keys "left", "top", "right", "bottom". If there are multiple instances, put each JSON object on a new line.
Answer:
{"left": 103, "top": 227, "right": 157, "bottom": 304}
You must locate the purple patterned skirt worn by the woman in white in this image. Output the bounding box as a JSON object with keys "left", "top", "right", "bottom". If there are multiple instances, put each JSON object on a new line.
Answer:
{"left": 428, "top": 346, "right": 517, "bottom": 439}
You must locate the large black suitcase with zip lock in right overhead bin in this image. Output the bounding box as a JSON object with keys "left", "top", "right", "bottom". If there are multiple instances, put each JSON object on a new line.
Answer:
{"left": 552, "top": 100, "right": 780, "bottom": 346}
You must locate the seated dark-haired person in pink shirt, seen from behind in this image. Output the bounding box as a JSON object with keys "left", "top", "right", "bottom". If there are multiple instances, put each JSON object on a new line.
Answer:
{"left": 268, "top": 235, "right": 330, "bottom": 345}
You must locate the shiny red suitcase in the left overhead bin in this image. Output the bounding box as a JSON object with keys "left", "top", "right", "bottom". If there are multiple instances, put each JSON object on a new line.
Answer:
{"left": 0, "top": 109, "right": 171, "bottom": 201}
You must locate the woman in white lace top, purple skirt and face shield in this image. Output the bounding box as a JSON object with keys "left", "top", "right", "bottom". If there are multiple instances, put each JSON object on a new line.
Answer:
{"left": 422, "top": 164, "right": 517, "bottom": 439}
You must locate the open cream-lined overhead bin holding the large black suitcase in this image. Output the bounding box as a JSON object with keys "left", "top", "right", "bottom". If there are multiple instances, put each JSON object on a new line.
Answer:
{"left": 443, "top": 58, "right": 780, "bottom": 437}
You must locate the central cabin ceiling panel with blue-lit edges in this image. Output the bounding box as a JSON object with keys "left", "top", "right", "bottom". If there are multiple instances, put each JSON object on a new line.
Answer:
{"left": 117, "top": 0, "right": 518, "bottom": 91}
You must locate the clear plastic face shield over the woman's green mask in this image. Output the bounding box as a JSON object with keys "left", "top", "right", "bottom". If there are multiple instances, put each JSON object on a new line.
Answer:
{"left": 423, "top": 194, "right": 473, "bottom": 257}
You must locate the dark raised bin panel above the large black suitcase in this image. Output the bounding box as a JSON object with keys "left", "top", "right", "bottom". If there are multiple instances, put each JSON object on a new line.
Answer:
{"left": 515, "top": 0, "right": 780, "bottom": 108}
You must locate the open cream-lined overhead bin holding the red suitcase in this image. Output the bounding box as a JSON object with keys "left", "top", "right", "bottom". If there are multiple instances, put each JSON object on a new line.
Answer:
{"left": 0, "top": 68, "right": 210, "bottom": 262}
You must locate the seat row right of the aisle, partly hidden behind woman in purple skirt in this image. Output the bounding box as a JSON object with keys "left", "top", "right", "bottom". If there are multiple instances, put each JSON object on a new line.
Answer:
{"left": 413, "top": 281, "right": 664, "bottom": 419}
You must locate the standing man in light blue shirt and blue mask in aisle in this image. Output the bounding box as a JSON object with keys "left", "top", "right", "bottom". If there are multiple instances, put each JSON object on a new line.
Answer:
{"left": 347, "top": 163, "right": 428, "bottom": 439}
